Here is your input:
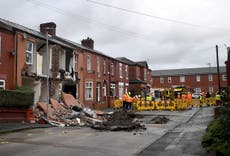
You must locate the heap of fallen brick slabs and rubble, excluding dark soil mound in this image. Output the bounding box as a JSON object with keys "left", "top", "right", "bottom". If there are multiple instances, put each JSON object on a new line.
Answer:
{"left": 34, "top": 93, "right": 106, "bottom": 127}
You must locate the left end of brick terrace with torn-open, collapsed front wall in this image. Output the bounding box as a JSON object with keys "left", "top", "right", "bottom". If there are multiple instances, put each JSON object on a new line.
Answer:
{"left": 0, "top": 19, "right": 78, "bottom": 119}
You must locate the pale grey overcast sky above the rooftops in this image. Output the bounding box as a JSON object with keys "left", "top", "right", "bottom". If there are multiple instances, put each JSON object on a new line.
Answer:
{"left": 0, "top": 0, "right": 230, "bottom": 70}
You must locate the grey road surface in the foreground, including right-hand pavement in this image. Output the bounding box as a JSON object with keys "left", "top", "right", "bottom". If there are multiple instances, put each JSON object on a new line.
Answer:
{"left": 0, "top": 107, "right": 213, "bottom": 156}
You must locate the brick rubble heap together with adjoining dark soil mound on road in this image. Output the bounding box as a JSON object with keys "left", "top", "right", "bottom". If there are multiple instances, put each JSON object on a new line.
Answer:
{"left": 34, "top": 93, "right": 145, "bottom": 131}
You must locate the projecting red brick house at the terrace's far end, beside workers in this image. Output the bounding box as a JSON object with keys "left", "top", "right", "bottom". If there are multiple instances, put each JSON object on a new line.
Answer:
{"left": 117, "top": 57, "right": 152, "bottom": 97}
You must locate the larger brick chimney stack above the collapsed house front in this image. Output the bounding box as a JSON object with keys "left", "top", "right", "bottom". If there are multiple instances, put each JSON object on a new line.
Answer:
{"left": 40, "top": 22, "right": 56, "bottom": 36}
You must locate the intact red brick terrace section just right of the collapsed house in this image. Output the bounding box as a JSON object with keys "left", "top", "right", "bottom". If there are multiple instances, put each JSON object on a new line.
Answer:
{"left": 68, "top": 38, "right": 129, "bottom": 109}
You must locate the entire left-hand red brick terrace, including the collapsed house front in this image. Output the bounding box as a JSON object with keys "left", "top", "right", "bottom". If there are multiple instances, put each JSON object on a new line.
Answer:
{"left": 0, "top": 19, "right": 152, "bottom": 109}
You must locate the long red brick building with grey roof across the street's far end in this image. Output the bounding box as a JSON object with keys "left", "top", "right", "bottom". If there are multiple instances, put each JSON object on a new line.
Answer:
{"left": 152, "top": 66, "right": 227, "bottom": 95}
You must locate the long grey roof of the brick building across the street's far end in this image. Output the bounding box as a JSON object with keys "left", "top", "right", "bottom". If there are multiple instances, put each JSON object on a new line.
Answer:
{"left": 151, "top": 66, "right": 226, "bottom": 76}
